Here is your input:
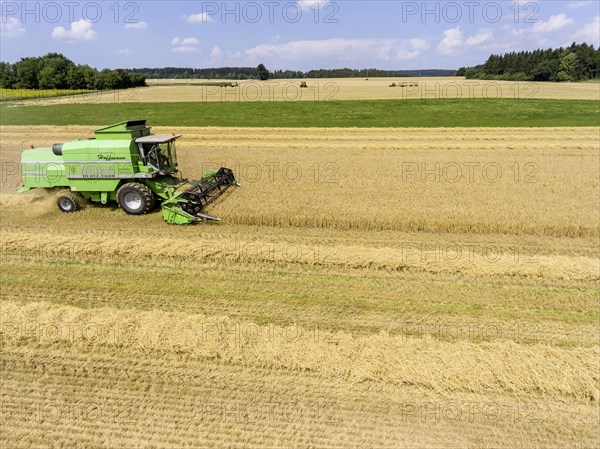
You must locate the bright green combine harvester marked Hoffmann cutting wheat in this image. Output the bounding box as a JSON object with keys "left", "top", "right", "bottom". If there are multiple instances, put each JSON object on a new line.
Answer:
{"left": 18, "top": 120, "right": 239, "bottom": 224}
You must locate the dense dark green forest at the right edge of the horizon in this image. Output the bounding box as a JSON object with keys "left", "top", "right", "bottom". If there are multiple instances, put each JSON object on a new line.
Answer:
{"left": 458, "top": 43, "right": 600, "bottom": 82}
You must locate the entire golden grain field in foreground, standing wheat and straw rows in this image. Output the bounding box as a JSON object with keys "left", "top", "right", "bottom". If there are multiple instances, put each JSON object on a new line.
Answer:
{"left": 0, "top": 126, "right": 600, "bottom": 448}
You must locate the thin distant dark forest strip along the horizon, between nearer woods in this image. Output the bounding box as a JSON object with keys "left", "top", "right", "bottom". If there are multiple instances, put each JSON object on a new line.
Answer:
{"left": 125, "top": 67, "right": 456, "bottom": 80}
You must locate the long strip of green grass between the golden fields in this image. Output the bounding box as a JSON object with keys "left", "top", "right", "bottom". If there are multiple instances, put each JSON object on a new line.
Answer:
{"left": 0, "top": 99, "right": 600, "bottom": 128}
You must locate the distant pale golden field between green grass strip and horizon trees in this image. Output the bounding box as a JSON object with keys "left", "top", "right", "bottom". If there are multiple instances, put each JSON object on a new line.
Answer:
{"left": 14, "top": 77, "right": 600, "bottom": 104}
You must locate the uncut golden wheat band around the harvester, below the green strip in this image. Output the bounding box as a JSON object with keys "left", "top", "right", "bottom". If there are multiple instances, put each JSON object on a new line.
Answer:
{"left": 2, "top": 126, "right": 600, "bottom": 237}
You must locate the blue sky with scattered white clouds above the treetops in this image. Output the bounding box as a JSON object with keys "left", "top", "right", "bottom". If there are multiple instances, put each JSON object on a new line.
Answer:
{"left": 0, "top": 0, "right": 600, "bottom": 70}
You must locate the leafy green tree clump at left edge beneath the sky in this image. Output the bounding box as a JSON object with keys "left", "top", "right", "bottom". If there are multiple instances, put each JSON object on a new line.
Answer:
{"left": 0, "top": 53, "right": 146, "bottom": 90}
